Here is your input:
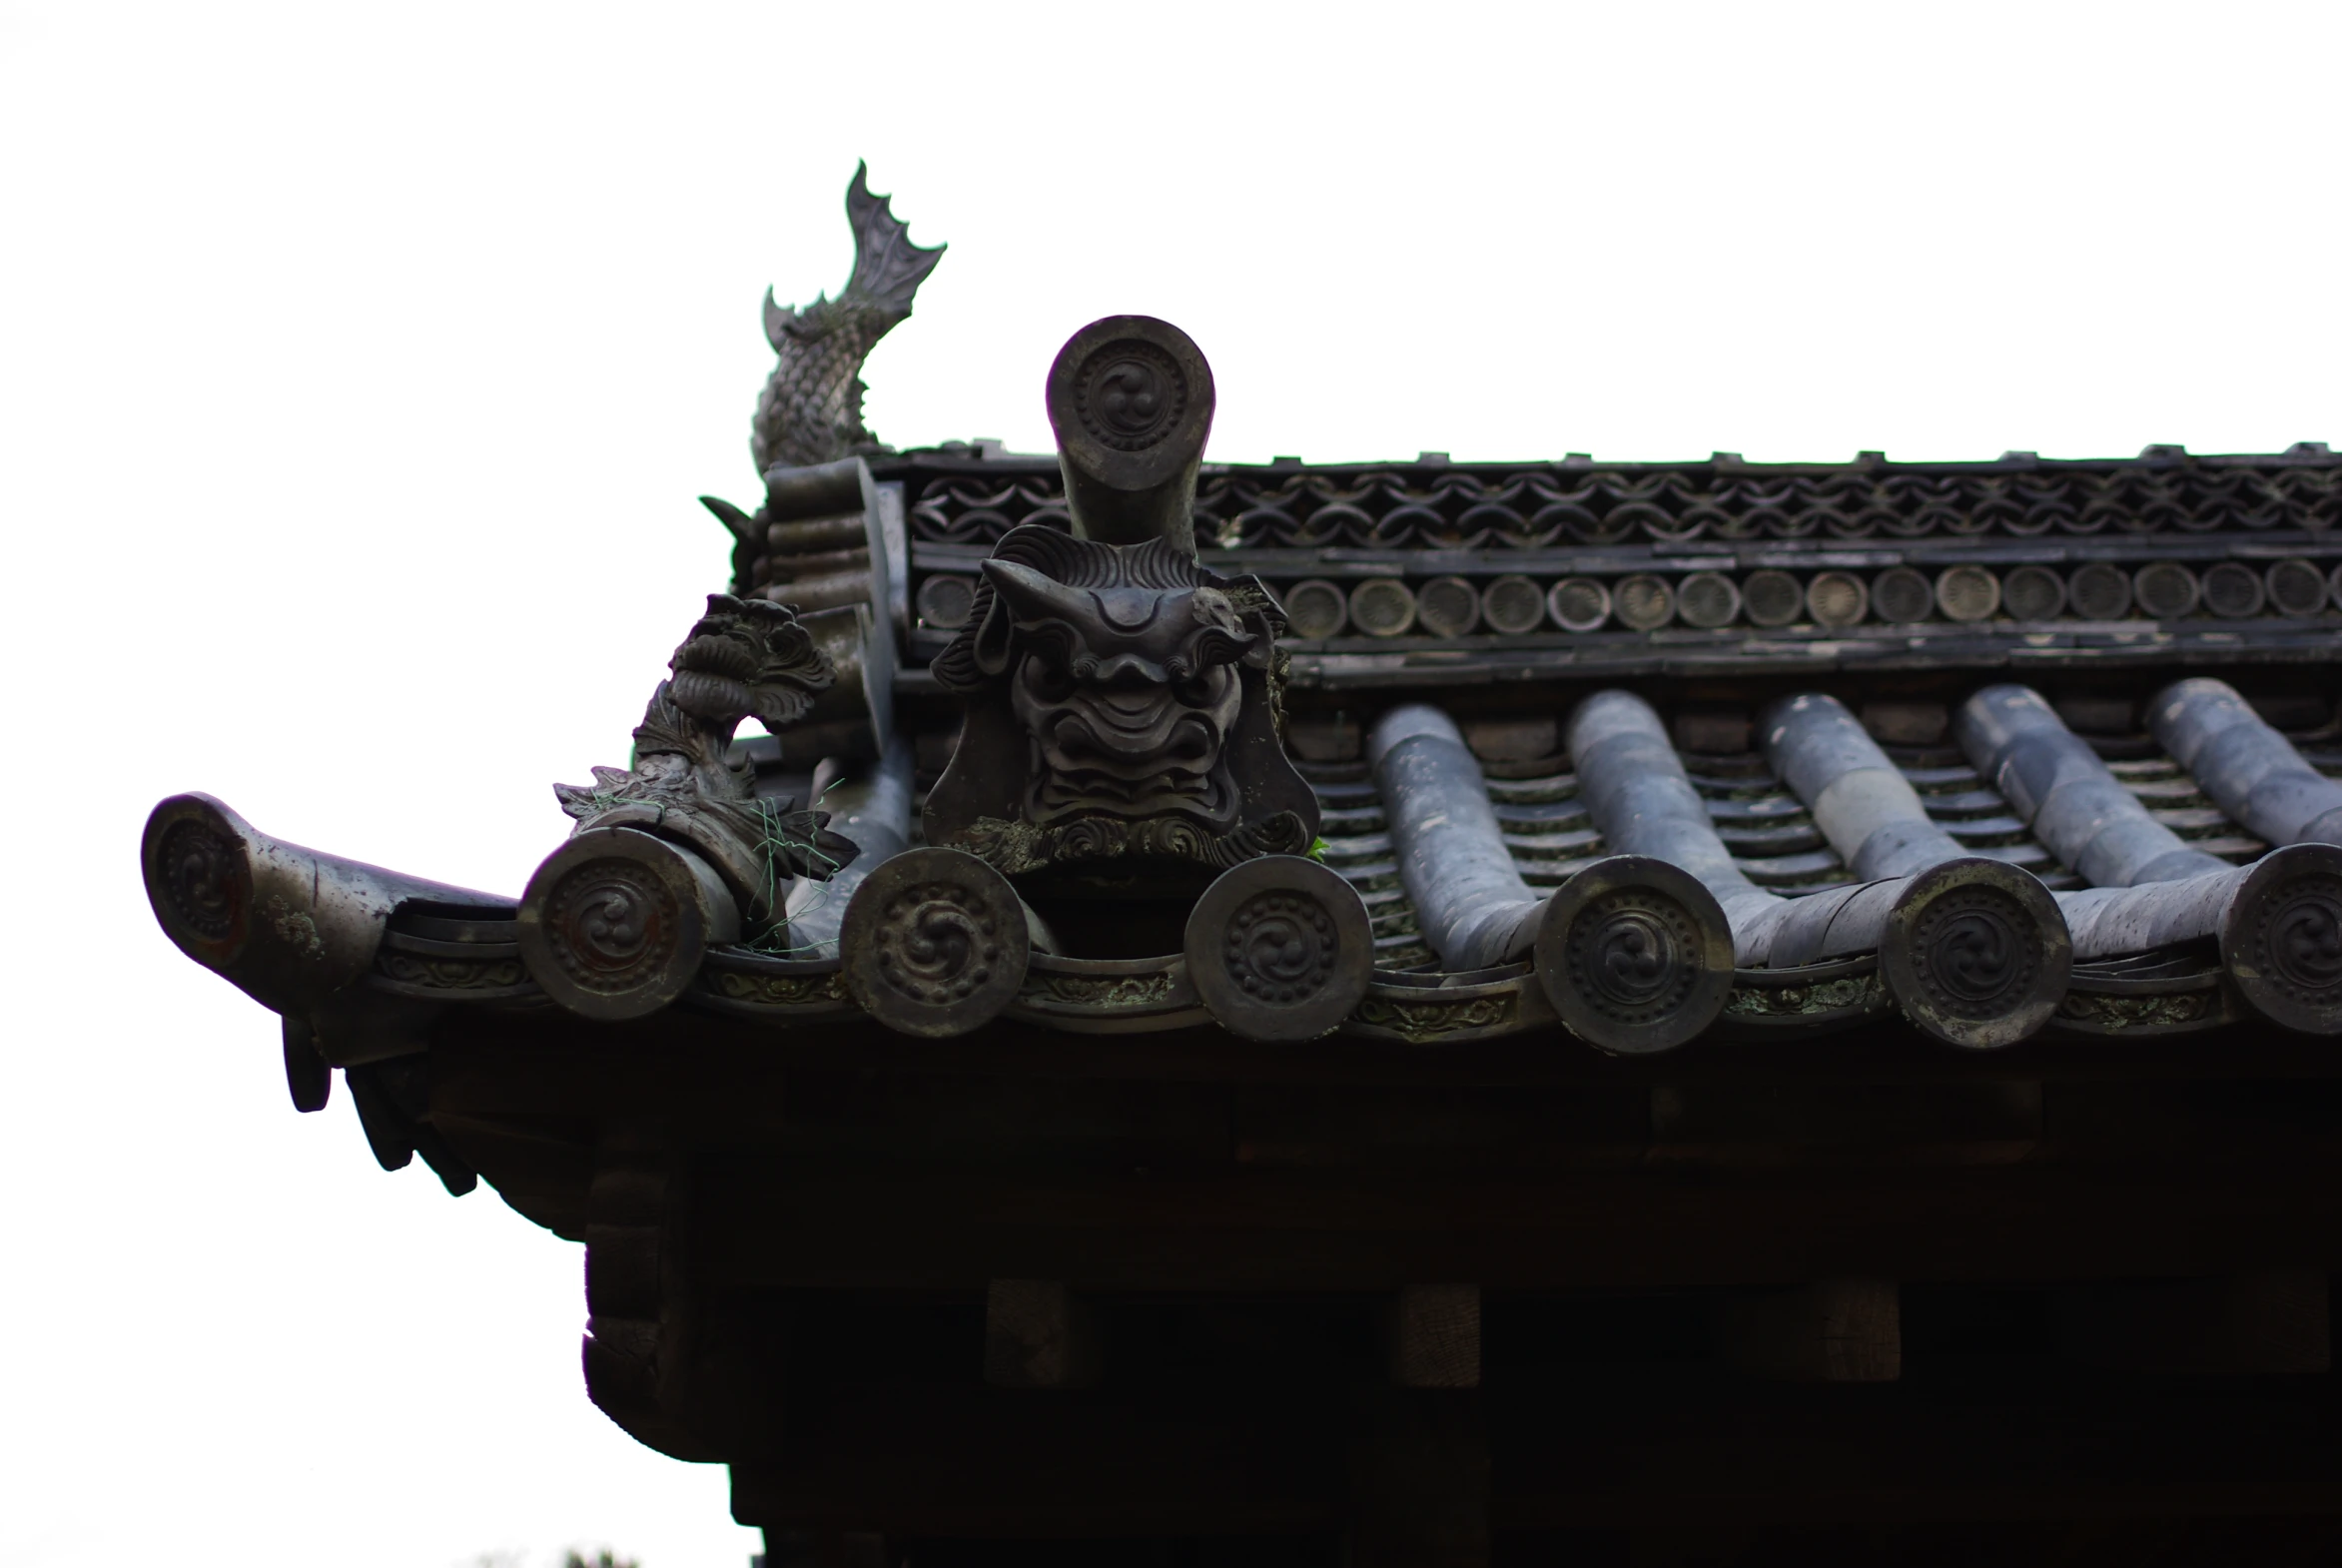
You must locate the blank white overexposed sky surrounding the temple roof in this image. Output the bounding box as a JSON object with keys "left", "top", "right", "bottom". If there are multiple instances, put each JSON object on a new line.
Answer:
{"left": 0, "top": 0, "right": 2342, "bottom": 1568}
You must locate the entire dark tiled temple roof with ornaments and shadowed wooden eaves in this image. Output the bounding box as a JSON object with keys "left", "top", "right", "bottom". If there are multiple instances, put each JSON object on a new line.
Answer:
{"left": 145, "top": 173, "right": 2342, "bottom": 1568}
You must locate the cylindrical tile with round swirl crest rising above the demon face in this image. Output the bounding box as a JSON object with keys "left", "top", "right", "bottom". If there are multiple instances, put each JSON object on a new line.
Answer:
{"left": 1050, "top": 316, "right": 1215, "bottom": 559}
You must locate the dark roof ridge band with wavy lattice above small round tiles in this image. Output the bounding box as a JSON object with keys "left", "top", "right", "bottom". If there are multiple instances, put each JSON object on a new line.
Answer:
{"left": 904, "top": 444, "right": 2342, "bottom": 686}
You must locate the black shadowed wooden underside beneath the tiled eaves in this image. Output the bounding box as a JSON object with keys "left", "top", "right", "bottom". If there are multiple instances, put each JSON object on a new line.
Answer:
{"left": 433, "top": 1011, "right": 2342, "bottom": 1561}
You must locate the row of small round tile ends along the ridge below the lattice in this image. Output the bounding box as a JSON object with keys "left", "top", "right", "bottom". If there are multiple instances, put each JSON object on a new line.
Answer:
{"left": 1264, "top": 559, "right": 2342, "bottom": 639}
